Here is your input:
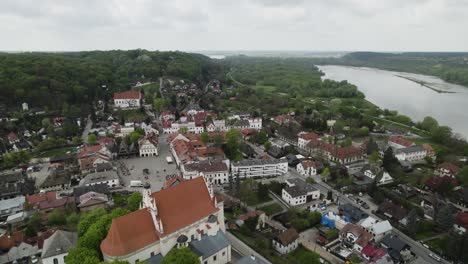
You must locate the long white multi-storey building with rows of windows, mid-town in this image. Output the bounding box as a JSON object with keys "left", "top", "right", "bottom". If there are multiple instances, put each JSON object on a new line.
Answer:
{"left": 231, "top": 159, "right": 288, "bottom": 178}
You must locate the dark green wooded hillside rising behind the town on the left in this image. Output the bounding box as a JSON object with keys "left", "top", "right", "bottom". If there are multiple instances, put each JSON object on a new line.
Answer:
{"left": 0, "top": 50, "right": 221, "bottom": 110}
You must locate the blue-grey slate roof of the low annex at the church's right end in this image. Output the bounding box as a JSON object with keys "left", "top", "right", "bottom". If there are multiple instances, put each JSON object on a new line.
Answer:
{"left": 189, "top": 231, "right": 230, "bottom": 259}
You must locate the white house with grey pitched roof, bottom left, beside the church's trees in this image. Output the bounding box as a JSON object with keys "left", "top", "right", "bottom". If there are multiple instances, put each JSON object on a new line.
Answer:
{"left": 41, "top": 230, "right": 78, "bottom": 264}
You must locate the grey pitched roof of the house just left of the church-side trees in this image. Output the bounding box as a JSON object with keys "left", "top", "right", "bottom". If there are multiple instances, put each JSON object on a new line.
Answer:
{"left": 41, "top": 230, "right": 78, "bottom": 258}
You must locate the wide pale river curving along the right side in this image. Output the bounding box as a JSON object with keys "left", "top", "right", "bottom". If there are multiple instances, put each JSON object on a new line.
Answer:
{"left": 318, "top": 65, "right": 468, "bottom": 138}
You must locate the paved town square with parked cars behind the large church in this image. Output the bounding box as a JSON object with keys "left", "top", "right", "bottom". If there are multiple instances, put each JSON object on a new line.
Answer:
{"left": 117, "top": 136, "right": 180, "bottom": 192}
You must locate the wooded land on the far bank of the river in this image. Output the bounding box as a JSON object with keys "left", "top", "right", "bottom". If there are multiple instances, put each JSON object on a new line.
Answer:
{"left": 316, "top": 52, "right": 468, "bottom": 87}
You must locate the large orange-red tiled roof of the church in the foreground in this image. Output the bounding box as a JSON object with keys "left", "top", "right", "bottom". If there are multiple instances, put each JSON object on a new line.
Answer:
{"left": 101, "top": 177, "right": 219, "bottom": 256}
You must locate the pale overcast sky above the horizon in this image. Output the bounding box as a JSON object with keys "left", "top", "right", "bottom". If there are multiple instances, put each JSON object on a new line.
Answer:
{"left": 0, "top": 0, "right": 468, "bottom": 51}
